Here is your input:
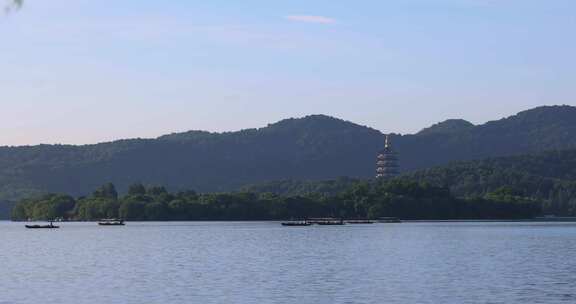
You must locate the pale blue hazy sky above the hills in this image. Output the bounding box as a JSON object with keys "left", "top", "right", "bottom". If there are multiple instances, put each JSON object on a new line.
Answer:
{"left": 0, "top": 0, "right": 576, "bottom": 145}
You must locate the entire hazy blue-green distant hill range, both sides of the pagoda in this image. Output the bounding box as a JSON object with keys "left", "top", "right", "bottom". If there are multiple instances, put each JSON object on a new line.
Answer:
{"left": 0, "top": 106, "right": 576, "bottom": 213}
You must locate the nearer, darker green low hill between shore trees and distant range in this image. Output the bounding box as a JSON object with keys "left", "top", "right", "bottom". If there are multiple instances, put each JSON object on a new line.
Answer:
{"left": 243, "top": 149, "right": 576, "bottom": 216}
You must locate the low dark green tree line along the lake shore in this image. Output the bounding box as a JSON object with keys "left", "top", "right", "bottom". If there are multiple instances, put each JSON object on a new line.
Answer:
{"left": 11, "top": 179, "right": 542, "bottom": 221}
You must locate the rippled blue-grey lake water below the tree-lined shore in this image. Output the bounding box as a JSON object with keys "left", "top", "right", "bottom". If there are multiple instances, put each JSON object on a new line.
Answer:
{"left": 0, "top": 222, "right": 576, "bottom": 304}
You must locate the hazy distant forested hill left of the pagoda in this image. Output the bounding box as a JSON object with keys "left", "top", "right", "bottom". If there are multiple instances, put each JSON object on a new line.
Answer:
{"left": 0, "top": 115, "right": 383, "bottom": 200}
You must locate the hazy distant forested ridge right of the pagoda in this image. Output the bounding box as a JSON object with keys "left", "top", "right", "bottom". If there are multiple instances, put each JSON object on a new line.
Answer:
{"left": 396, "top": 106, "right": 576, "bottom": 170}
